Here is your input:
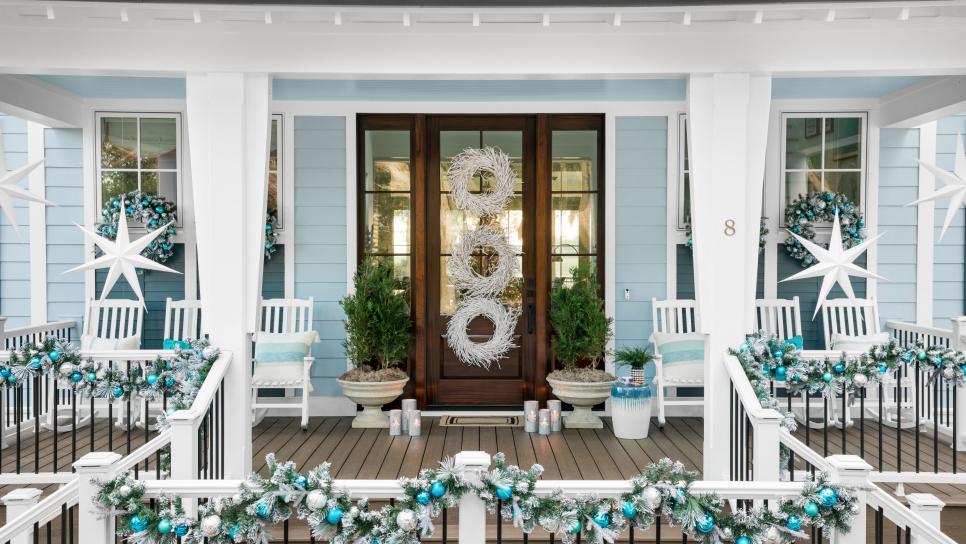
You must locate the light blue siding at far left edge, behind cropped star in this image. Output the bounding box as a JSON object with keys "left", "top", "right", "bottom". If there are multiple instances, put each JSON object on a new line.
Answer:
{"left": 0, "top": 114, "right": 30, "bottom": 327}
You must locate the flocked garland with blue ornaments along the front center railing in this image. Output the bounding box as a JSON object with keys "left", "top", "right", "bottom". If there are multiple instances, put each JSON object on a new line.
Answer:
{"left": 96, "top": 453, "right": 857, "bottom": 544}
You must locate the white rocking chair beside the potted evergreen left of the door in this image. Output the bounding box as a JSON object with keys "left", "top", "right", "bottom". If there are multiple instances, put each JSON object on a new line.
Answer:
{"left": 252, "top": 297, "right": 319, "bottom": 430}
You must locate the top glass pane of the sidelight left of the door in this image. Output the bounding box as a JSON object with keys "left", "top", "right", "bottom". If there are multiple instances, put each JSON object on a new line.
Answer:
{"left": 365, "top": 130, "right": 410, "bottom": 191}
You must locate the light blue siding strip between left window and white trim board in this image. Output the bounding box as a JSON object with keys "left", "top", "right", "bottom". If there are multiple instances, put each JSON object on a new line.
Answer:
{"left": 44, "top": 128, "right": 84, "bottom": 332}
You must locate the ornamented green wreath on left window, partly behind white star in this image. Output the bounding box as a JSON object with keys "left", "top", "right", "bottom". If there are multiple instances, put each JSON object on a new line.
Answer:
{"left": 95, "top": 191, "right": 178, "bottom": 264}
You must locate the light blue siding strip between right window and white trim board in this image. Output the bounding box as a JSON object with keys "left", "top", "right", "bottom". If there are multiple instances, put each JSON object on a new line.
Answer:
{"left": 877, "top": 128, "right": 919, "bottom": 323}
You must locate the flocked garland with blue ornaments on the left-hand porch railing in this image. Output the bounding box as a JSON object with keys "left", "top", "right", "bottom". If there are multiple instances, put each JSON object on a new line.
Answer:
{"left": 0, "top": 337, "right": 219, "bottom": 428}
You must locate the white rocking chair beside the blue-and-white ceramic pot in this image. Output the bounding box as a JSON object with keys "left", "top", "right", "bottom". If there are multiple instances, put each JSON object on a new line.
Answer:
{"left": 651, "top": 298, "right": 704, "bottom": 427}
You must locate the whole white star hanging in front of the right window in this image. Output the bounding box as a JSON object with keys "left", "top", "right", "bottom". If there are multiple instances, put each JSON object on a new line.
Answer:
{"left": 782, "top": 211, "right": 884, "bottom": 319}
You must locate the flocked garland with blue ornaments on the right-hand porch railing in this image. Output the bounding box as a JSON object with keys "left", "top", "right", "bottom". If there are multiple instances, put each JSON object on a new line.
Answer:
{"left": 730, "top": 333, "right": 966, "bottom": 431}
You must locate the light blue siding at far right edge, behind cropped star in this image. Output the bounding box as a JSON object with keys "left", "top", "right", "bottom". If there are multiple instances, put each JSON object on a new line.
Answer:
{"left": 933, "top": 114, "right": 966, "bottom": 328}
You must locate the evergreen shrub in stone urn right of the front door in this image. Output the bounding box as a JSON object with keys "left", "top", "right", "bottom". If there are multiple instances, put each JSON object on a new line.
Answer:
{"left": 547, "top": 263, "right": 615, "bottom": 429}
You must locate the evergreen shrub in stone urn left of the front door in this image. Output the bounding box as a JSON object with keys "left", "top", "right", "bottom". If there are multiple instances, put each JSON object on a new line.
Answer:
{"left": 336, "top": 261, "right": 412, "bottom": 429}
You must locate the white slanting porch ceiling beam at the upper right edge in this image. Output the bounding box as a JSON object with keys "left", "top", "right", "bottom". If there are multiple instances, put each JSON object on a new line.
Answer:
{"left": 879, "top": 76, "right": 966, "bottom": 128}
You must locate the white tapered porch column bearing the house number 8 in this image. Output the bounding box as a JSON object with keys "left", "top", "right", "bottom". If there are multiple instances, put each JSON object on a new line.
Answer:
{"left": 688, "top": 74, "right": 771, "bottom": 480}
